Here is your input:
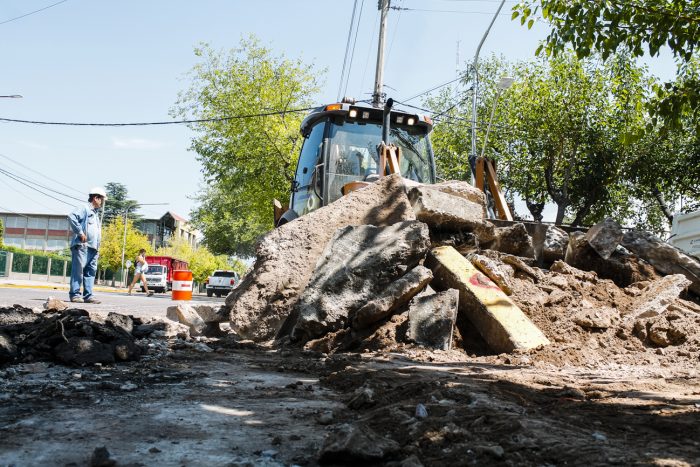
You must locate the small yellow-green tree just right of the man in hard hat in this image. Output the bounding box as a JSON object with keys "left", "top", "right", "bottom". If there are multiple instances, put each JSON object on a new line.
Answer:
{"left": 99, "top": 216, "right": 153, "bottom": 278}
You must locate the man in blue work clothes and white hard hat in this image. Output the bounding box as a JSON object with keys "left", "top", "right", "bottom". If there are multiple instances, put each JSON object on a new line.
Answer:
{"left": 68, "top": 187, "right": 107, "bottom": 303}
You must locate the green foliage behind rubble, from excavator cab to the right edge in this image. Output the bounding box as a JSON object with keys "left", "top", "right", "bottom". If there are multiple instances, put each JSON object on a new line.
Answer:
{"left": 426, "top": 53, "right": 700, "bottom": 230}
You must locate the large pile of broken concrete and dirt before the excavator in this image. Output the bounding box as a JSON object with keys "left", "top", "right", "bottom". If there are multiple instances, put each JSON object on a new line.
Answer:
{"left": 218, "top": 176, "right": 700, "bottom": 357}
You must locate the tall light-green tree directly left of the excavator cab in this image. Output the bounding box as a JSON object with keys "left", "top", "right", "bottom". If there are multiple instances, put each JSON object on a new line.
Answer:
{"left": 172, "top": 37, "right": 319, "bottom": 254}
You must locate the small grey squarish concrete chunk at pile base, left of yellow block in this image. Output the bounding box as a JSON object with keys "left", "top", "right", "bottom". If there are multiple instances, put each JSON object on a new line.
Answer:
{"left": 408, "top": 289, "right": 459, "bottom": 350}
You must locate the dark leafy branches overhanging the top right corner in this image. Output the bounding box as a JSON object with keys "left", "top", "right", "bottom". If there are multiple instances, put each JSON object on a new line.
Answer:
{"left": 512, "top": 0, "right": 700, "bottom": 127}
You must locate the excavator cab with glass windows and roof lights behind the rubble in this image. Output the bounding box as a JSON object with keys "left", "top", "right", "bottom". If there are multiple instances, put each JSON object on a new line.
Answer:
{"left": 275, "top": 101, "right": 435, "bottom": 226}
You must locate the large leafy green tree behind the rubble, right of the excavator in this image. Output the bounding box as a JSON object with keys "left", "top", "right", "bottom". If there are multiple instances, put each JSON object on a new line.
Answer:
{"left": 428, "top": 54, "right": 648, "bottom": 225}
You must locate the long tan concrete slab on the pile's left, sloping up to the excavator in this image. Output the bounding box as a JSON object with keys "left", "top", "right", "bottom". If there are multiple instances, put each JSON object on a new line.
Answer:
{"left": 226, "top": 175, "right": 415, "bottom": 341}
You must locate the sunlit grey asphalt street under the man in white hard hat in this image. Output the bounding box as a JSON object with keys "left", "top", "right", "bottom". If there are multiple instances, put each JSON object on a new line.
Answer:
{"left": 0, "top": 287, "right": 224, "bottom": 318}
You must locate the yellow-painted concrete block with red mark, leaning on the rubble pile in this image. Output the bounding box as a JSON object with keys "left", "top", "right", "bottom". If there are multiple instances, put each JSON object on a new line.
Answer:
{"left": 426, "top": 247, "right": 549, "bottom": 353}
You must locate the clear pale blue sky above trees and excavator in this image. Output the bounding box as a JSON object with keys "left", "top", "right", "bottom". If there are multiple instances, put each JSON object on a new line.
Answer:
{"left": 0, "top": 0, "right": 675, "bottom": 220}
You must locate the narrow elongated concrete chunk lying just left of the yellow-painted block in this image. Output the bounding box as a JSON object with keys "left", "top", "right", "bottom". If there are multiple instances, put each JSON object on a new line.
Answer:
{"left": 352, "top": 266, "right": 433, "bottom": 329}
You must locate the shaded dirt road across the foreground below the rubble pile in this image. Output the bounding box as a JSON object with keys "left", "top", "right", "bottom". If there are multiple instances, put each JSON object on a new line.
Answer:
{"left": 0, "top": 341, "right": 700, "bottom": 466}
